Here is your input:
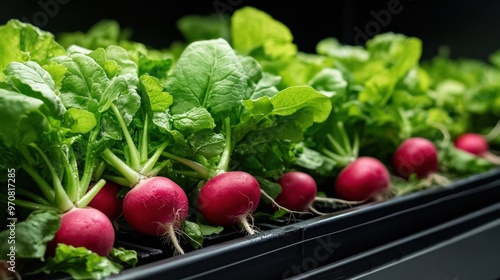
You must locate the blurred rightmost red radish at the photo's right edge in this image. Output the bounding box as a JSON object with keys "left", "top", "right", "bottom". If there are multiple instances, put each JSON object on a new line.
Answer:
{"left": 454, "top": 132, "right": 500, "bottom": 165}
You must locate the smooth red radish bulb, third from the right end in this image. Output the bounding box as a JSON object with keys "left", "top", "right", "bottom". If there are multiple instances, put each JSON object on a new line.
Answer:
{"left": 335, "top": 157, "right": 390, "bottom": 201}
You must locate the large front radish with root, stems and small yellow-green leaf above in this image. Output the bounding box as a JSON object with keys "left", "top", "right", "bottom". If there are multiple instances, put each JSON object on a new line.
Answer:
{"left": 92, "top": 75, "right": 193, "bottom": 254}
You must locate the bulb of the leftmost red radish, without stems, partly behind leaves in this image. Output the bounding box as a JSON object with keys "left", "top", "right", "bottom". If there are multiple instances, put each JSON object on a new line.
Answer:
{"left": 47, "top": 207, "right": 115, "bottom": 256}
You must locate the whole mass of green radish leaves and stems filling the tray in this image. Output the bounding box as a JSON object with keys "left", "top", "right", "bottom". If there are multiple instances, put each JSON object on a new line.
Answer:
{"left": 0, "top": 6, "right": 500, "bottom": 279}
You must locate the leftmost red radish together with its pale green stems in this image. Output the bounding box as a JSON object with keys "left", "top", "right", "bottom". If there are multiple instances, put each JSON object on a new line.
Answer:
{"left": 16, "top": 144, "right": 115, "bottom": 256}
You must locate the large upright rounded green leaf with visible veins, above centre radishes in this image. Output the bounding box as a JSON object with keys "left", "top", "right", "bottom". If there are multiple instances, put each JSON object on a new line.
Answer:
{"left": 166, "top": 39, "right": 247, "bottom": 122}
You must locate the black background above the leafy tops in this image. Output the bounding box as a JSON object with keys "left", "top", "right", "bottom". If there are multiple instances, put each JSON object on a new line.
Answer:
{"left": 0, "top": 0, "right": 500, "bottom": 60}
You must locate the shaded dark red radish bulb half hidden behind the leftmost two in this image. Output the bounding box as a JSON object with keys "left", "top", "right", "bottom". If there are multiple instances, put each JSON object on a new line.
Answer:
{"left": 87, "top": 181, "right": 123, "bottom": 221}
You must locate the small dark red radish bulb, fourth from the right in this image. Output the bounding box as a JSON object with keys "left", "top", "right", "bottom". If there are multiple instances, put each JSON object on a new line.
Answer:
{"left": 275, "top": 171, "right": 318, "bottom": 211}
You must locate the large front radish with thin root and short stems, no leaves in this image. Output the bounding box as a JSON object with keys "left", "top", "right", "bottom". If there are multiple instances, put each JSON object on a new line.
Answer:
{"left": 102, "top": 120, "right": 189, "bottom": 254}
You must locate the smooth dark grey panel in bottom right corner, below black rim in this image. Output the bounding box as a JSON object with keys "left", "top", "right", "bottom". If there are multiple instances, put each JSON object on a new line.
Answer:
{"left": 289, "top": 199, "right": 500, "bottom": 280}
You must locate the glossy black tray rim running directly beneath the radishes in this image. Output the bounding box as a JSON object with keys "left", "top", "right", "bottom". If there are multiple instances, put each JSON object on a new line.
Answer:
{"left": 106, "top": 169, "right": 500, "bottom": 280}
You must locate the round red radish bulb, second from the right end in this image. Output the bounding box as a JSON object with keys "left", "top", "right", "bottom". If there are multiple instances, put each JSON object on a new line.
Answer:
{"left": 392, "top": 137, "right": 438, "bottom": 179}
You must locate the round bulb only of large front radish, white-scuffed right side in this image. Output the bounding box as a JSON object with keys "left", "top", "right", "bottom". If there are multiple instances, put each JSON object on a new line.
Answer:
{"left": 123, "top": 176, "right": 189, "bottom": 236}
